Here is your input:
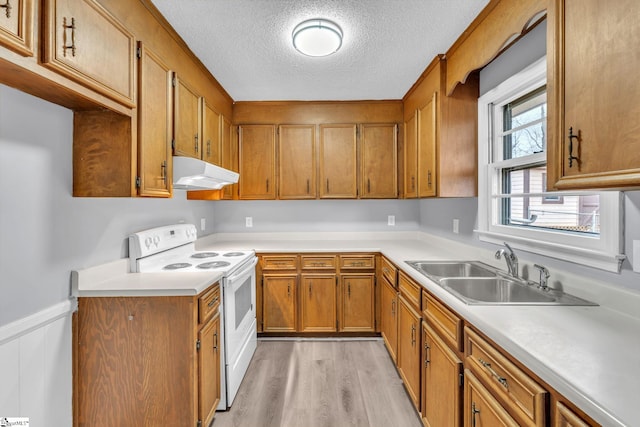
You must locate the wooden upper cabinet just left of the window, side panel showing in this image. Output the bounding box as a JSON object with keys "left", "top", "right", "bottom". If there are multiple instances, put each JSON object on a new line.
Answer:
{"left": 403, "top": 56, "right": 478, "bottom": 198}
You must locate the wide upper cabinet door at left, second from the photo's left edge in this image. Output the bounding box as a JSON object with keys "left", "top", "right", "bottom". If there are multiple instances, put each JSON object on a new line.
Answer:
{"left": 42, "top": 0, "right": 135, "bottom": 107}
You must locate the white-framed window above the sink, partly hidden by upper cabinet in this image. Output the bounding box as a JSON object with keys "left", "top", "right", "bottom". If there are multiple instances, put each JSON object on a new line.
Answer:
{"left": 477, "top": 58, "right": 624, "bottom": 271}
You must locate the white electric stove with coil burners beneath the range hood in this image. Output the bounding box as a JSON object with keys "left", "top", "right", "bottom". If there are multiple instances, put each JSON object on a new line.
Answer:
{"left": 129, "top": 224, "right": 258, "bottom": 410}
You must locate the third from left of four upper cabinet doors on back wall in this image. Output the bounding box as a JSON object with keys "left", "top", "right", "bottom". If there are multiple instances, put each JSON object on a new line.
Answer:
{"left": 319, "top": 124, "right": 358, "bottom": 199}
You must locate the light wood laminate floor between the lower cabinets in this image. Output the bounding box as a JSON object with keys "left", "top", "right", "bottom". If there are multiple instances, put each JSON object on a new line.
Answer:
{"left": 212, "top": 340, "right": 422, "bottom": 427}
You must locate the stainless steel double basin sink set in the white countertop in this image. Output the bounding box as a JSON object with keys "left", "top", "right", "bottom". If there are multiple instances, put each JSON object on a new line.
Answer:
{"left": 406, "top": 261, "right": 597, "bottom": 305}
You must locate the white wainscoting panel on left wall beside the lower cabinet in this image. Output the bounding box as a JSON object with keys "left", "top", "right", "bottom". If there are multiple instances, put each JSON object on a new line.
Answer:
{"left": 0, "top": 301, "right": 75, "bottom": 427}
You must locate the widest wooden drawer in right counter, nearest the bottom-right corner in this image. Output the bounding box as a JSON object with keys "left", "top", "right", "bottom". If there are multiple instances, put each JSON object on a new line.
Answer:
{"left": 464, "top": 327, "right": 547, "bottom": 426}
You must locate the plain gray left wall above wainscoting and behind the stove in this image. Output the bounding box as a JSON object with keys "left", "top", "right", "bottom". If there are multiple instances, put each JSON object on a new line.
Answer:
{"left": 0, "top": 86, "right": 214, "bottom": 326}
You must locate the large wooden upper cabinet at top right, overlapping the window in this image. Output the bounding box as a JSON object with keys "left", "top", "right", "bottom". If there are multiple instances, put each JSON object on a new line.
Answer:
{"left": 547, "top": 0, "right": 640, "bottom": 190}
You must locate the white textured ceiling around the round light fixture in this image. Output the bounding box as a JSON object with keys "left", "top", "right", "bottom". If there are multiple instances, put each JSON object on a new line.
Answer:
{"left": 152, "top": 0, "right": 488, "bottom": 101}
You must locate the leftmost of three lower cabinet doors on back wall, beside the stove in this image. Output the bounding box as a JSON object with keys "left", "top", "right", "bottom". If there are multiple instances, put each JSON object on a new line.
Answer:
{"left": 262, "top": 274, "right": 298, "bottom": 332}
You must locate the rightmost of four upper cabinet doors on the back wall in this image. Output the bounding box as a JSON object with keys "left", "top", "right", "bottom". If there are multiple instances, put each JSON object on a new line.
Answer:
{"left": 360, "top": 124, "right": 398, "bottom": 199}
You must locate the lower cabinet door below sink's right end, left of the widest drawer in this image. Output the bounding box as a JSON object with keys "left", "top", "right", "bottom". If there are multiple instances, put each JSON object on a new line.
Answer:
{"left": 422, "top": 323, "right": 464, "bottom": 427}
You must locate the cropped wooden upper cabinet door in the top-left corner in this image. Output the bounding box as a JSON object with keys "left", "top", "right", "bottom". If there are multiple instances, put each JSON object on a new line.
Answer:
{"left": 0, "top": 0, "right": 34, "bottom": 56}
